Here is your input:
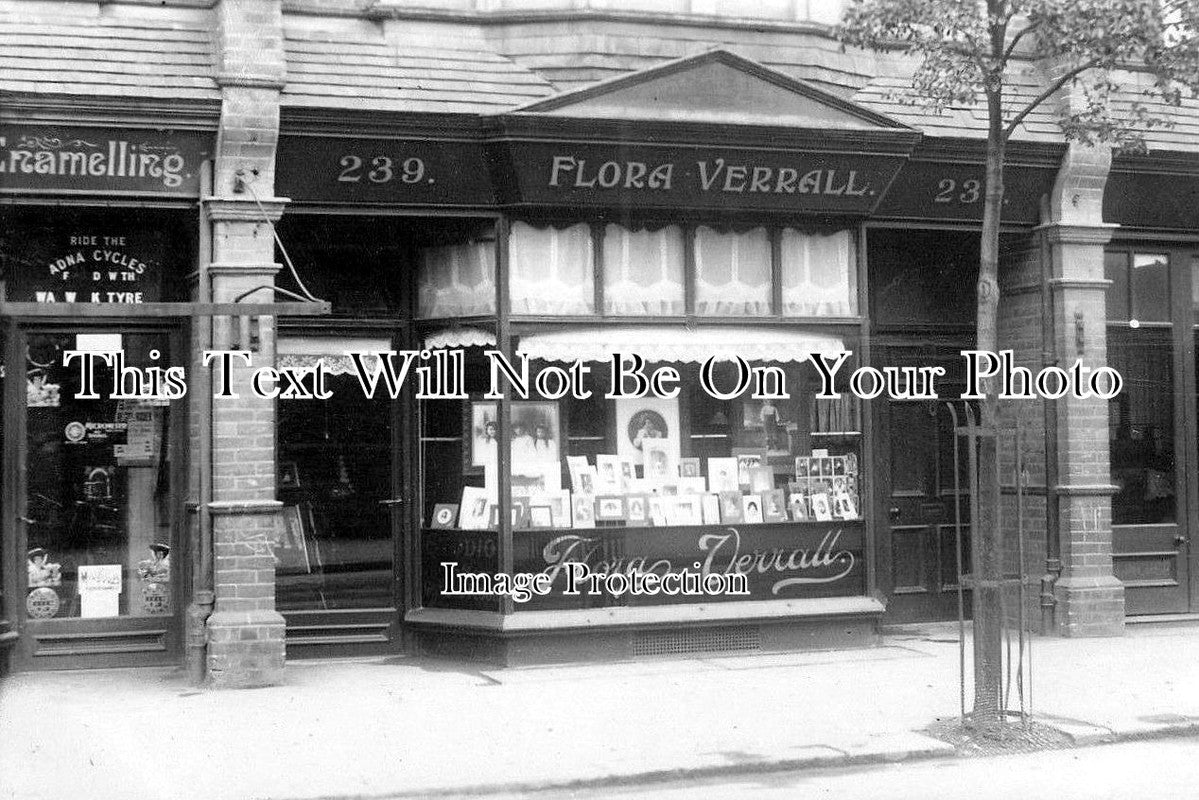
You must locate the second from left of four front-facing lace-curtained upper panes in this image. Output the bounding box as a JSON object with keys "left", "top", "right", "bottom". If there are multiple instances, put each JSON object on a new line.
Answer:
{"left": 603, "top": 224, "right": 685, "bottom": 317}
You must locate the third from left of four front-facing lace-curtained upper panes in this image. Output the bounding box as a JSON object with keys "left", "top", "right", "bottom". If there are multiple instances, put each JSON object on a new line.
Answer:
{"left": 695, "top": 225, "right": 771, "bottom": 317}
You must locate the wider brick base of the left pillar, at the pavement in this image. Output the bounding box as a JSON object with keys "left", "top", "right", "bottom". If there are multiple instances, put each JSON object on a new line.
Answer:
{"left": 207, "top": 610, "right": 285, "bottom": 688}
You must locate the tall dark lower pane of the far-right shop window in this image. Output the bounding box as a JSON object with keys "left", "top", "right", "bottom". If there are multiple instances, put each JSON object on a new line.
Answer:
{"left": 1108, "top": 327, "right": 1176, "bottom": 524}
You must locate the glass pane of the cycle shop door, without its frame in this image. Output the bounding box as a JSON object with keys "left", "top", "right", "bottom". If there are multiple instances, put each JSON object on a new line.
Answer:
{"left": 25, "top": 333, "right": 173, "bottom": 619}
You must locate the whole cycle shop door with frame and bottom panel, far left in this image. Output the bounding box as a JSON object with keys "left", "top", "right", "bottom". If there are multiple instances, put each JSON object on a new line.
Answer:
{"left": 4, "top": 324, "right": 187, "bottom": 669}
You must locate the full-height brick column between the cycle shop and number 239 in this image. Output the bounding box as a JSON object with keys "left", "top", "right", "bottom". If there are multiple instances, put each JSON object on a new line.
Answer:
{"left": 206, "top": 0, "right": 285, "bottom": 687}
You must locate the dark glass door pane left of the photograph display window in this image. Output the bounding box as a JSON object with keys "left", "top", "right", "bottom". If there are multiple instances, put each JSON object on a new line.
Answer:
{"left": 276, "top": 371, "right": 394, "bottom": 610}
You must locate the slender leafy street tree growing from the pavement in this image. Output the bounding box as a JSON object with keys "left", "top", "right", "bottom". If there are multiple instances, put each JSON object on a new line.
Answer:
{"left": 837, "top": 0, "right": 1199, "bottom": 728}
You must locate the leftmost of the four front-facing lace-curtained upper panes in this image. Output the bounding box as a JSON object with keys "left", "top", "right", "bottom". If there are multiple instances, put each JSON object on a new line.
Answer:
{"left": 508, "top": 222, "right": 595, "bottom": 315}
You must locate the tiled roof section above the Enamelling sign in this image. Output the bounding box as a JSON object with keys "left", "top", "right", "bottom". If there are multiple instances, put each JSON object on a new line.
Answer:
{"left": 0, "top": 0, "right": 221, "bottom": 101}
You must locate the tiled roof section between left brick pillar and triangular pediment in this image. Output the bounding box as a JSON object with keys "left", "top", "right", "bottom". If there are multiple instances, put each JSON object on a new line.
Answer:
{"left": 283, "top": 19, "right": 553, "bottom": 113}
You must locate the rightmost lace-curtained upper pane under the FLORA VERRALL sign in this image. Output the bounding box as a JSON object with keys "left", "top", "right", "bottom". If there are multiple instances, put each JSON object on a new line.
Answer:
{"left": 781, "top": 228, "right": 857, "bottom": 317}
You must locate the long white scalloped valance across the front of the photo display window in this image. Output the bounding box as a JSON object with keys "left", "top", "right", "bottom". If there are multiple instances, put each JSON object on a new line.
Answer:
{"left": 517, "top": 325, "right": 845, "bottom": 363}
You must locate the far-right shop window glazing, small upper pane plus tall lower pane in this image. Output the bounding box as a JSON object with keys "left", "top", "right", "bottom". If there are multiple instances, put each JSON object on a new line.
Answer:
{"left": 1104, "top": 251, "right": 1177, "bottom": 524}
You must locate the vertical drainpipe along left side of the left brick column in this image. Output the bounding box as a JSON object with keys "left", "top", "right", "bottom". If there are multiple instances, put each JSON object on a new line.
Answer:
{"left": 186, "top": 161, "right": 216, "bottom": 686}
